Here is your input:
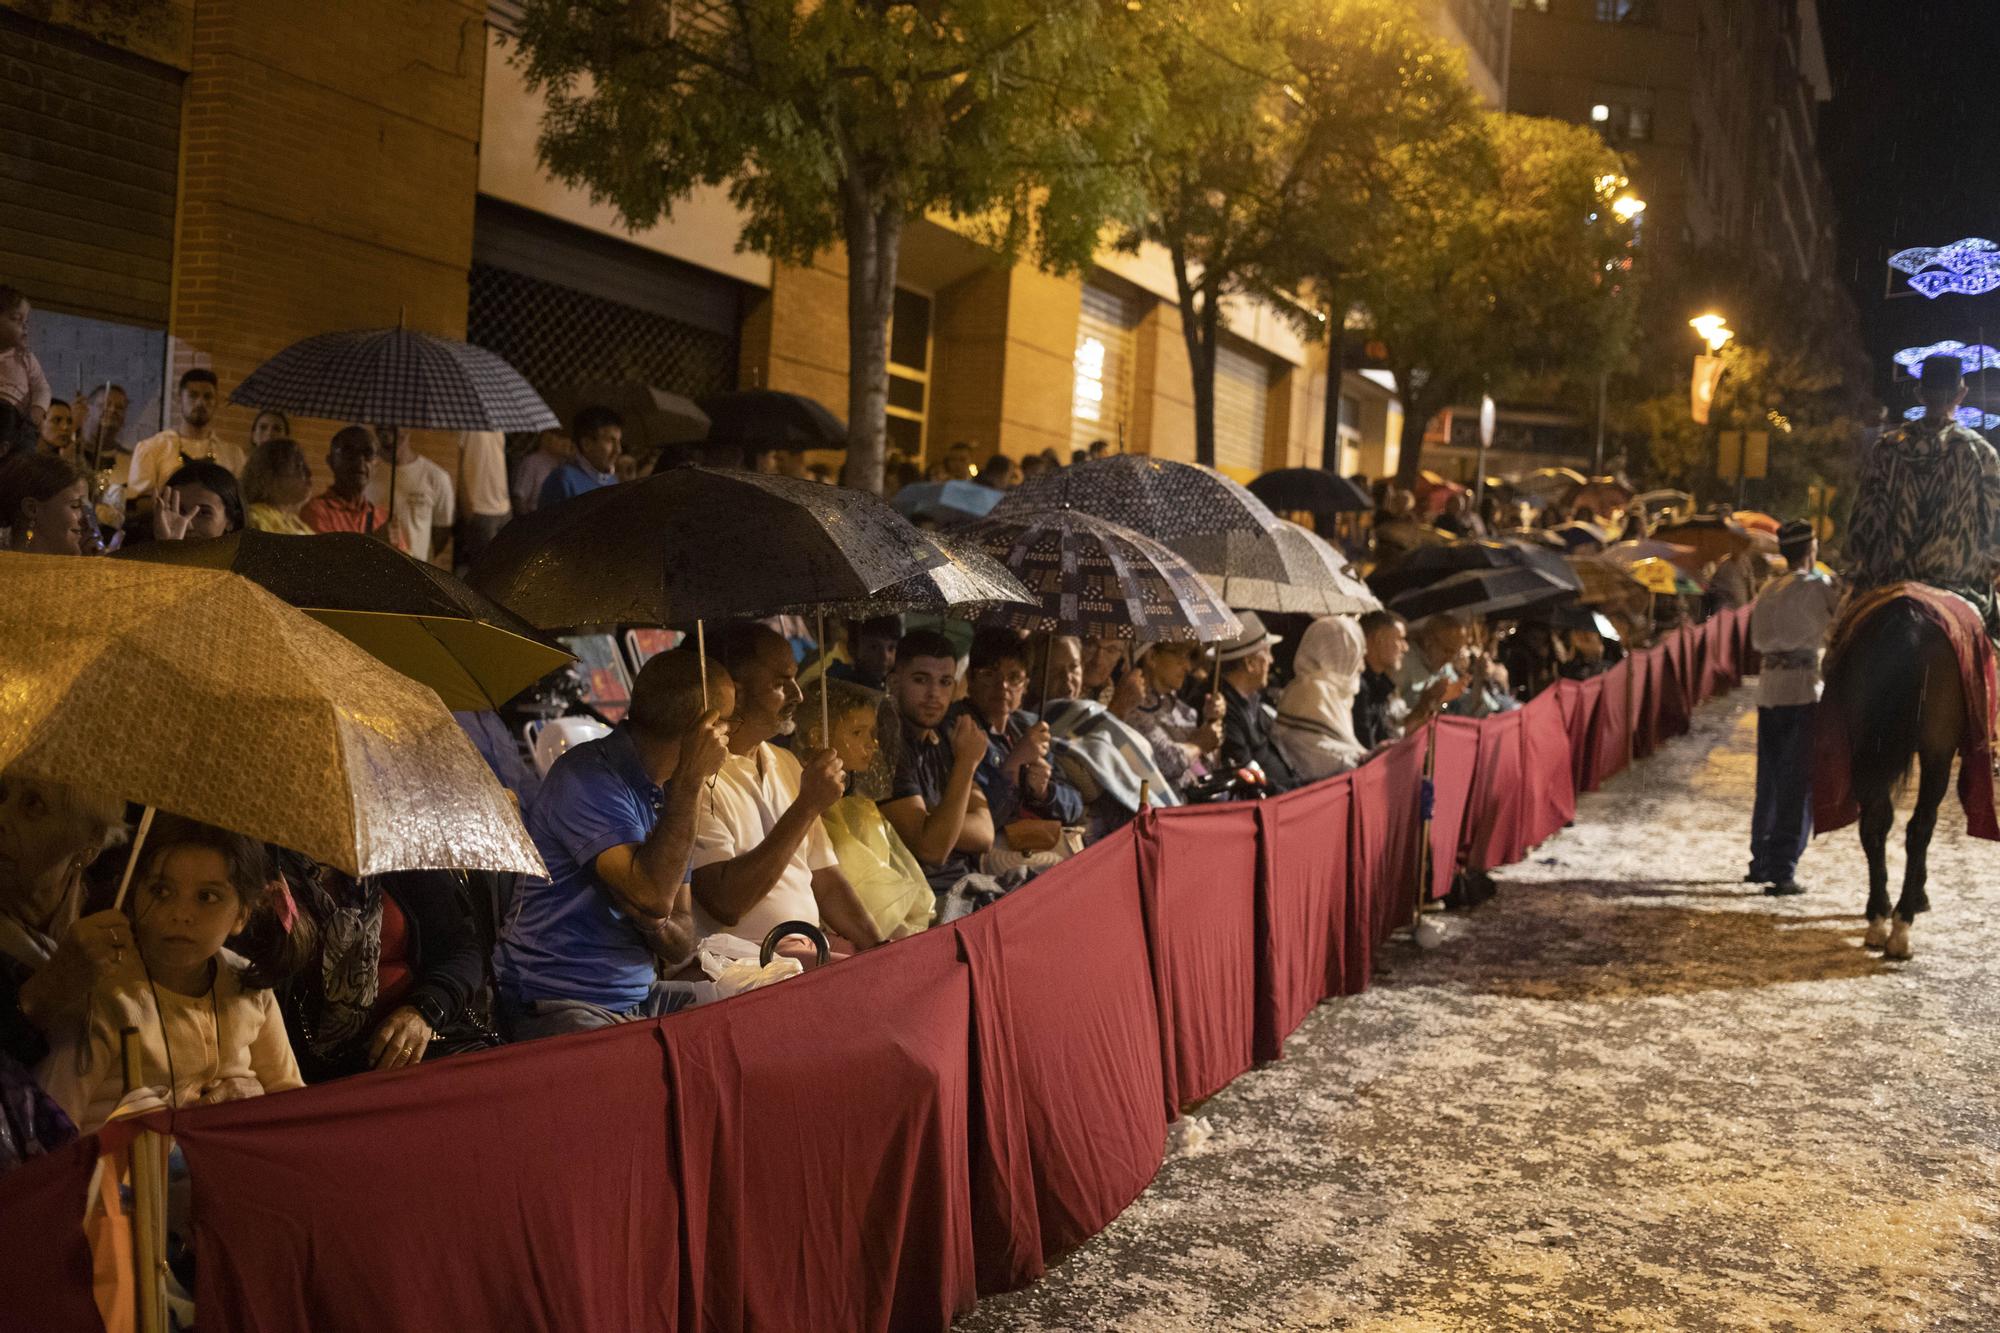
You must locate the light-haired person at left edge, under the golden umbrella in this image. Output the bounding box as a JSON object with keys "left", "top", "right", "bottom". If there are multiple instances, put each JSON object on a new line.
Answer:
{"left": 0, "top": 775, "right": 134, "bottom": 1065}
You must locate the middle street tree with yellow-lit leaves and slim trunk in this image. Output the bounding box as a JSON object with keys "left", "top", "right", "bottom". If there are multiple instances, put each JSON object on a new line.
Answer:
{"left": 1124, "top": 0, "right": 1476, "bottom": 464}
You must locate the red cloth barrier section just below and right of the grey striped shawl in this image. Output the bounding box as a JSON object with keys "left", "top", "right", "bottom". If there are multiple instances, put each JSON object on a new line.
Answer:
{"left": 1138, "top": 805, "right": 1258, "bottom": 1107}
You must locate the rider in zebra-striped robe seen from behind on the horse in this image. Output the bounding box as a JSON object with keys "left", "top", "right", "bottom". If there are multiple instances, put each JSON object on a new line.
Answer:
{"left": 1846, "top": 354, "right": 2000, "bottom": 638}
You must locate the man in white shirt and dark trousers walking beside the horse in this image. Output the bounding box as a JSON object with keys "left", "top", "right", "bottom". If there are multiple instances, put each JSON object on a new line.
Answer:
{"left": 1744, "top": 522, "right": 1840, "bottom": 897}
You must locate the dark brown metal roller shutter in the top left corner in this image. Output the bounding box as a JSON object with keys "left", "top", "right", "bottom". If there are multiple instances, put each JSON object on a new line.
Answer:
{"left": 0, "top": 10, "right": 182, "bottom": 328}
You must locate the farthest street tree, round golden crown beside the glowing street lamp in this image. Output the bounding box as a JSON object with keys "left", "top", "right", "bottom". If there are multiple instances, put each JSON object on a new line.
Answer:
{"left": 1354, "top": 112, "right": 1634, "bottom": 486}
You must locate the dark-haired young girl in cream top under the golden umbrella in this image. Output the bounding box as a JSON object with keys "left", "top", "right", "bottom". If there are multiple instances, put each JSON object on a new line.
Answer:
{"left": 42, "top": 815, "right": 310, "bottom": 1133}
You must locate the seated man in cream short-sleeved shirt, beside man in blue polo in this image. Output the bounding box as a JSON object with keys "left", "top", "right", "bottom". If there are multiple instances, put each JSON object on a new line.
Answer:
{"left": 694, "top": 624, "right": 884, "bottom": 951}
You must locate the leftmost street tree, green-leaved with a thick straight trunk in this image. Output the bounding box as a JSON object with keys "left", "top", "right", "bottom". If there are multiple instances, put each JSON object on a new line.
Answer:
{"left": 516, "top": 0, "right": 1156, "bottom": 490}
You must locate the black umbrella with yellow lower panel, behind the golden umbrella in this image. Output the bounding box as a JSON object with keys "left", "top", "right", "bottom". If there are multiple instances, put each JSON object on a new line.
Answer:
{"left": 120, "top": 530, "right": 572, "bottom": 711}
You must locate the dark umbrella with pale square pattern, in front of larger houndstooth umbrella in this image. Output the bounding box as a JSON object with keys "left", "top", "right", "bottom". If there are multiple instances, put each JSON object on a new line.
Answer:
{"left": 964, "top": 508, "right": 1242, "bottom": 642}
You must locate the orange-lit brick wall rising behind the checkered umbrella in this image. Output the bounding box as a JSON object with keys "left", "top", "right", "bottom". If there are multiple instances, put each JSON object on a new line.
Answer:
{"left": 170, "top": 0, "right": 486, "bottom": 470}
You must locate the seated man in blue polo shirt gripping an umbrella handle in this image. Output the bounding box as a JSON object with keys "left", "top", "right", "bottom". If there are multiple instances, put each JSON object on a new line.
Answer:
{"left": 494, "top": 648, "right": 736, "bottom": 1041}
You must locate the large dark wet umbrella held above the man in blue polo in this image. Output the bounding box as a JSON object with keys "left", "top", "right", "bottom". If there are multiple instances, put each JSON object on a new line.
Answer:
{"left": 470, "top": 468, "right": 948, "bottom": 628}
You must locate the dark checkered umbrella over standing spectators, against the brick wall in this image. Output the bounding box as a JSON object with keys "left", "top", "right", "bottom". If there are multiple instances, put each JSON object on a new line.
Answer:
{"left": 230, "top": 326, "right": 562, "bottom": 430}
